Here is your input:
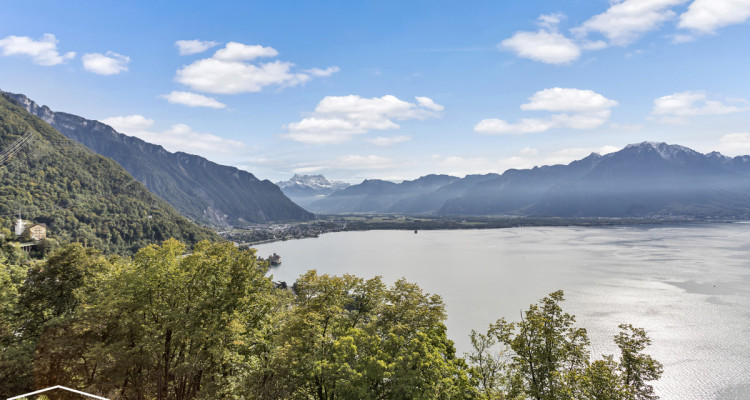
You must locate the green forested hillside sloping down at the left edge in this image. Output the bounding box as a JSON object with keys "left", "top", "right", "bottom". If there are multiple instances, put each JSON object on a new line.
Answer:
{"left": 0, "top": 95, "right": 218, "bottom": 254}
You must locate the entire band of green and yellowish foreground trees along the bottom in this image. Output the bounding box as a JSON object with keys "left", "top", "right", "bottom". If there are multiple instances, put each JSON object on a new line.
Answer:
{"left": 0, "top": 240, "right": 661, "bottom": 400}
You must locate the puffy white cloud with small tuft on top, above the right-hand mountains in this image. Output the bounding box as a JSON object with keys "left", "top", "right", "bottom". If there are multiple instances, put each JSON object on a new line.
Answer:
{"left": 498, "top": 14, "right": 581, "bottom": 64}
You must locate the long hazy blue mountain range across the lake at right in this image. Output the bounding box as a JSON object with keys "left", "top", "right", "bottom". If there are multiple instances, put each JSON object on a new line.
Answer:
{"left": 309, "top": 142, "right": 750, "bottom": 218}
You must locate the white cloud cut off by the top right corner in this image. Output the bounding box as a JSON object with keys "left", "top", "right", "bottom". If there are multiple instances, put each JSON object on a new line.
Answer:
{"left": 678, "top": 0, "right": 750, "bottom": 33}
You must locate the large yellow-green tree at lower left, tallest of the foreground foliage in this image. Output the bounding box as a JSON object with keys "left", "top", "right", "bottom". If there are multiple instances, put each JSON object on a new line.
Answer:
{"left": 70, "top": 240, "right": 271, "bottom": 400}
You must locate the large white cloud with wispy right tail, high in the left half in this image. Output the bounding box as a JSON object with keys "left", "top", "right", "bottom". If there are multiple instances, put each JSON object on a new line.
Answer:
{"left": 175, "top": 42, "right": 339, "bottom": 94}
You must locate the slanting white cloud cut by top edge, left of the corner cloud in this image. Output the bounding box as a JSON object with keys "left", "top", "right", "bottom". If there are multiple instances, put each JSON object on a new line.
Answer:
{"left": 573, "top": 0, "right": 692, "bottom": 46}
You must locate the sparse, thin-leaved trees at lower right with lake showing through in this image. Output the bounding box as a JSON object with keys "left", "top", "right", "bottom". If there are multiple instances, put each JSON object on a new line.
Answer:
{"left": 476, "top": 291, "right": 662, "bottom": 400}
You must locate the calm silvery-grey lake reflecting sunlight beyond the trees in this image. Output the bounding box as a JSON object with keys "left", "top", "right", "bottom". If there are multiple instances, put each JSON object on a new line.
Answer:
{"left": 256, "top": 223, "right": 750, "bottom": 400}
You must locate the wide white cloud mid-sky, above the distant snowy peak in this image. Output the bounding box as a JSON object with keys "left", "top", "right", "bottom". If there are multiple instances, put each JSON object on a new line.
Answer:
{"left": 282, "top": 95, "right": 443, "bottom": 144}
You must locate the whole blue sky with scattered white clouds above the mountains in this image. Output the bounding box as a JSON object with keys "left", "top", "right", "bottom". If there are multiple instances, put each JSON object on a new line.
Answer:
{"left": 0, "top": 0, "right": 750, "bottom": 182}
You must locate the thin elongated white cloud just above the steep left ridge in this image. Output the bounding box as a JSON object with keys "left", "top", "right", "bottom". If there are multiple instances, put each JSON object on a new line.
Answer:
{"left": 101, "top": 115, "right": 247, "bottom": 156}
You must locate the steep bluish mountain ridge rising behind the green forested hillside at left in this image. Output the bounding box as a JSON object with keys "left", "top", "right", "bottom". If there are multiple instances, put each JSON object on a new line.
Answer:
{"left": 7, "top": 93, "right": 314, "bottom": 226}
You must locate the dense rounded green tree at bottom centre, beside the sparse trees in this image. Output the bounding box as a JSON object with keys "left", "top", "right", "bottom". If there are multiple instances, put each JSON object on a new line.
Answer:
{"left": 251, "top": 271, "right": 474, "bottom": 400}
